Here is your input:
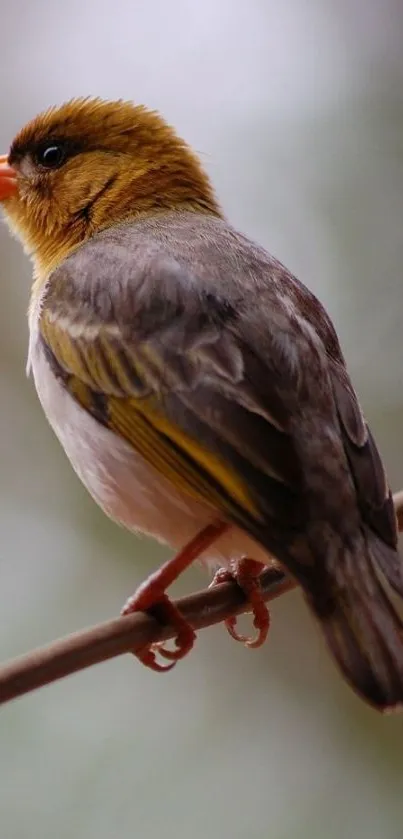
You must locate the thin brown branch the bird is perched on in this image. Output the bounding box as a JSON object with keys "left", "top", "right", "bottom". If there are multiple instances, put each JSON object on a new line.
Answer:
{"left": 0, "top": 491, "right": 403, "bottom": 704}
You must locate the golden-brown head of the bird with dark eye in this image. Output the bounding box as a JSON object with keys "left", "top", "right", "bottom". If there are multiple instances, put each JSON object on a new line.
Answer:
{"left": 0, "top": 99, "right": 220, "bottom": 276}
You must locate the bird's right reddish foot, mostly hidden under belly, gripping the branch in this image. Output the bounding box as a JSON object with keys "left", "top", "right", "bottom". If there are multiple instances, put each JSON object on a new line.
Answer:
{"left": 210, "top": 557, "right": 270, "bottom": 649}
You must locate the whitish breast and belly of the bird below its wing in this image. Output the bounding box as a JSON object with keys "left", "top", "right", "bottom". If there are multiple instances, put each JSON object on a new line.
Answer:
{"left": 29, "top": 324, "right": 270, "bottom": 567}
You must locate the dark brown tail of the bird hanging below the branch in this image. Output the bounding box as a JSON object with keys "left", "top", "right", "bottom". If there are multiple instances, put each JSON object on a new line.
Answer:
{"left": 298, "top": 530, "right": 403, "bottom": 710}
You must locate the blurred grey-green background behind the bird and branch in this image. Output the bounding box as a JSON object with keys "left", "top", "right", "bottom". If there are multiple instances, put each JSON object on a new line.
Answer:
{"left": 0, "top": 0, "right": 403, "bottom": 839}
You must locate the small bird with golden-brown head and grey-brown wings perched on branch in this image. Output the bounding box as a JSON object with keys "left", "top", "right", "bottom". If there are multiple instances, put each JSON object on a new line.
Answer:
{"left": 0, "top": 98, "right": 403, "bottom": 709}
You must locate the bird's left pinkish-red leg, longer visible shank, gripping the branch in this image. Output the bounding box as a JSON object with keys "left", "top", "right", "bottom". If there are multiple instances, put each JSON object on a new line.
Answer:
{"left": 122, "top": 521, "right": 229, "bottom": 672}
